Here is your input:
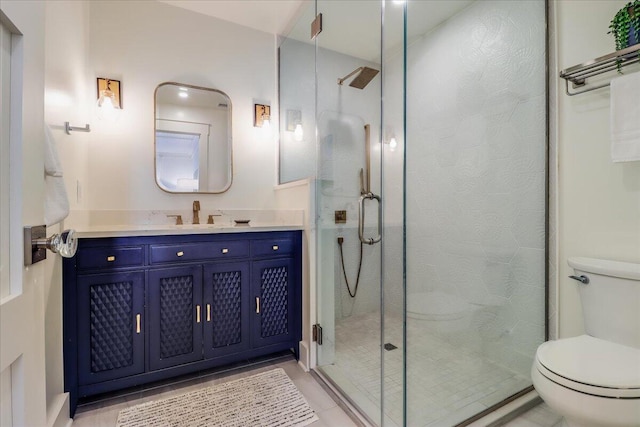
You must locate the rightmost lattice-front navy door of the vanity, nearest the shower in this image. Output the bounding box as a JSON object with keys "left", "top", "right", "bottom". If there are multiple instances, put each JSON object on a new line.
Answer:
{"left": 251, "top": 258, "right": 296, "bottom": 348}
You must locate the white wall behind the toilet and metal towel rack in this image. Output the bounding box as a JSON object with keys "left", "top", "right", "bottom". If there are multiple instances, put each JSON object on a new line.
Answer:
{"left": 556, "top": 0, "right": 640, "bottom": 337}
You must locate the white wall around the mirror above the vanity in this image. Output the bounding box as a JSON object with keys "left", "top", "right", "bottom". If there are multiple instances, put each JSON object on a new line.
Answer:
{"left": 81, "top": 1, "right": 277, "bottom": 211}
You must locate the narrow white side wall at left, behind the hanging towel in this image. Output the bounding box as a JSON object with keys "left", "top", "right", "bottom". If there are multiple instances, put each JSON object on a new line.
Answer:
{"left": 44, "top": 1, "right": 89, "bottom": 418}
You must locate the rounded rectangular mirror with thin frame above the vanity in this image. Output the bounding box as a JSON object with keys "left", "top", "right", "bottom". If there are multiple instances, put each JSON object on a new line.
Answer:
{"left": 154, "top": 82, "right": 233, "bottom": 193}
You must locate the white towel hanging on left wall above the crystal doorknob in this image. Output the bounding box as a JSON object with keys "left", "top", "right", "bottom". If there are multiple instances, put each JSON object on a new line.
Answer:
{"left": 44, "top": 125, "right": 69, "bottom": 226}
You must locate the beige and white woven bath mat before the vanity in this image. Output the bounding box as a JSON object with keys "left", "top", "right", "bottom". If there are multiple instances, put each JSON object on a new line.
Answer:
{"left": 116, "top": 368, "right": 318, "bottom": 427}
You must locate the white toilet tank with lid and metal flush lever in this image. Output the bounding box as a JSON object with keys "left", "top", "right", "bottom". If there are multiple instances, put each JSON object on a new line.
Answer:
{"left": 567, "top": 258, "right": 640, "bottom": 349}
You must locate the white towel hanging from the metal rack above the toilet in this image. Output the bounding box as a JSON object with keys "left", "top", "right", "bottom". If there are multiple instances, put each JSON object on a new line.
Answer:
{"left": 611, "top": 72, "right": 640, "bottom": 162}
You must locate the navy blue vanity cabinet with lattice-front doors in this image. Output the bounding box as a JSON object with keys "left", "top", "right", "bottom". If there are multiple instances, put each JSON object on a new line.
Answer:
{"left": 63, "top": 231, "right": 302, "bottom": 417}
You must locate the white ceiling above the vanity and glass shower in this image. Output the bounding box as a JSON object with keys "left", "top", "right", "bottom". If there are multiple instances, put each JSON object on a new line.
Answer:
{"left": 158, "top": 0, "right": 475, "bottom": 63}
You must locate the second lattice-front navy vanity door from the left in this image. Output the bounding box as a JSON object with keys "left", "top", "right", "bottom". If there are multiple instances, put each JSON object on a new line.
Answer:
{"left": 147, "top": 265, "right": 203, "bottom": 369}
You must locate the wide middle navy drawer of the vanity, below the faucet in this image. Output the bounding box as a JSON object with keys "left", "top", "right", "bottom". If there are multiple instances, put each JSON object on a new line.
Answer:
{"left": 150, "top": 242, "right": 249, "bottom": 264}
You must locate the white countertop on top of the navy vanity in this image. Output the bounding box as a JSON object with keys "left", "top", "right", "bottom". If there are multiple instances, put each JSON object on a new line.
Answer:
{"left": 75, "top": 222, "right": 304, "bottom": 239}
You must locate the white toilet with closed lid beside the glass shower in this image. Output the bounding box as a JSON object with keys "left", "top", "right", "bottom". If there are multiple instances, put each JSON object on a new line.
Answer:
{"left": 531, "top": 258, "right": 640, "bottom": 427}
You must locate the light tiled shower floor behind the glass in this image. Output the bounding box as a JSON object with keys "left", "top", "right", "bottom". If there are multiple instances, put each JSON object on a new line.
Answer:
{"left": 323, "top": 313, "right": 531, "bottom": 427}
